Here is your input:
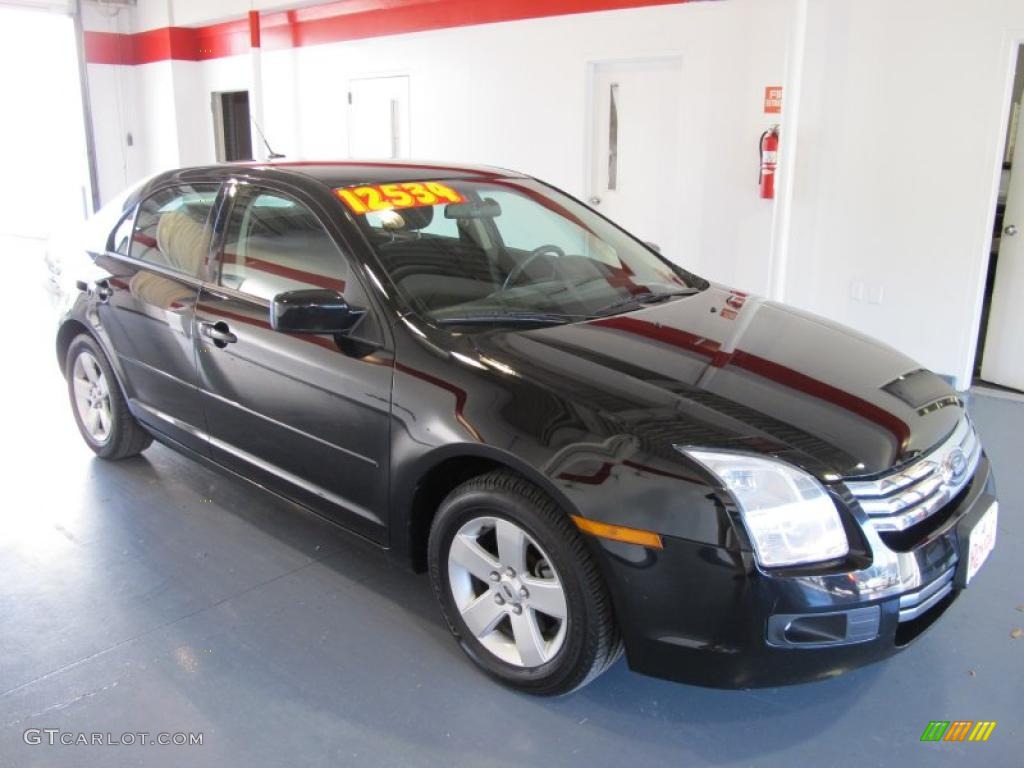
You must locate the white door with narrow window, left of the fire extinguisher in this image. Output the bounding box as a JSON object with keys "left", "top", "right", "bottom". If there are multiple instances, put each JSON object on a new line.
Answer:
{"left": 588, "top": 58, "right": 682, "bottom": 261}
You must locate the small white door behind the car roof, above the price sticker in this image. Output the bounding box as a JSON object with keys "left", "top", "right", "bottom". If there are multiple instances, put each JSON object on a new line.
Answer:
{"left": 348, "top": 75, "right": 409, "bottom": 160}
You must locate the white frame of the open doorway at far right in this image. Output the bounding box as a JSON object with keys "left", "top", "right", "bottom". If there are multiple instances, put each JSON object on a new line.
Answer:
{"left": 957, "top": 29, "right": 1024, "bottom": 390}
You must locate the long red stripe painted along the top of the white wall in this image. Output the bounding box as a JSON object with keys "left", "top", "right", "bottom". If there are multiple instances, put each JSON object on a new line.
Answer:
{"left": 85, "top": 0, "right": 695, "bottom": 65}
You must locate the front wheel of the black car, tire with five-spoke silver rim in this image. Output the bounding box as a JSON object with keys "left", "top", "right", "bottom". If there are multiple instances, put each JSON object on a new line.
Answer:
{"left": 428, "top": 470, "right": 623, "bottom": 695}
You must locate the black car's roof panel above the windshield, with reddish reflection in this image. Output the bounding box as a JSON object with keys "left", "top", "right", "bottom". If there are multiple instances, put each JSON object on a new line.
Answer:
{"left": 154, "top": 160, "right": 524, "bottom": 187}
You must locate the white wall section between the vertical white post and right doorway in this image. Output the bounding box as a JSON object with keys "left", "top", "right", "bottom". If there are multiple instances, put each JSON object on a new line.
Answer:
{"left": 784, "top": 0, "right": 1024, "bottom": 387}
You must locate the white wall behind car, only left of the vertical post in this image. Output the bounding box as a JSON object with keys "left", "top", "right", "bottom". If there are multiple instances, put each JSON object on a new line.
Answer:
{"left": 119, "top": 0, "right": 792, "bottom": 292}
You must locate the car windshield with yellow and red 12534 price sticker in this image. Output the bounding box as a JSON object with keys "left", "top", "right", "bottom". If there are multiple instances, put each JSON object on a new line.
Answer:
{"left": 336, "top": 178, "right": 707, "bottom": 325}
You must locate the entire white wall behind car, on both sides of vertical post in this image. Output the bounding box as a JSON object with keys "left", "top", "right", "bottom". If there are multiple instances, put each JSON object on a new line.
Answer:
{"left": 81, "top": 0, "right": 1024, "bottom": 386}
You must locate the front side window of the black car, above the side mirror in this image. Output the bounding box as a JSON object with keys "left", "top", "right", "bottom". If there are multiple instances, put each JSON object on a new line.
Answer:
{"left": 219, "top": 187, "right": 361, "bottom": 304}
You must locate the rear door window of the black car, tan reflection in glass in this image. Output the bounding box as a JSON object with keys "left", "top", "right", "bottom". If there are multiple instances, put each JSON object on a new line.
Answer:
{"left": 130, "top": 184, "right": 219, "bottom": 278}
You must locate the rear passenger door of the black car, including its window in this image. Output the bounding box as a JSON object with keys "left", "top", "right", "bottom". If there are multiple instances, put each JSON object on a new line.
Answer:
{"left": 90, "top": 183, "right": 220, "bottom": 455}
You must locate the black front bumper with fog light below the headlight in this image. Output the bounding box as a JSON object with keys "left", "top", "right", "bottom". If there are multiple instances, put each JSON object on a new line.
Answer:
{"left": 599, "top": 456, "right": 994, "bottom": 688}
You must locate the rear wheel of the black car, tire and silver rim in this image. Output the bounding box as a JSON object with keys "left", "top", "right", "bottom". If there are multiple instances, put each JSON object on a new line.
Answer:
{"left": 65, "top": 334, "right": 153, "bottom": 461}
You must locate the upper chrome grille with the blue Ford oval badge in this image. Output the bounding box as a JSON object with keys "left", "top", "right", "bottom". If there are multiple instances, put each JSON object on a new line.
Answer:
{"left": 846, "top": 416, "right": 981, "bottom": 534}
